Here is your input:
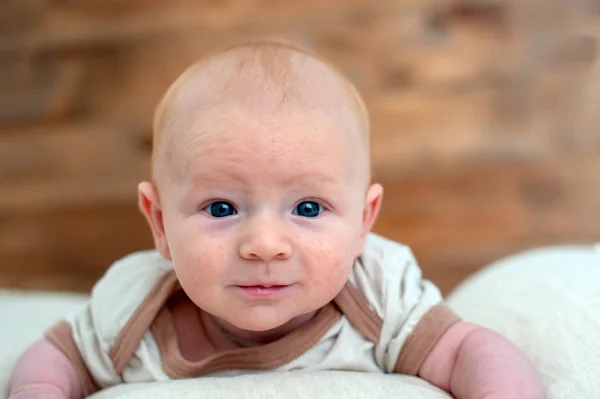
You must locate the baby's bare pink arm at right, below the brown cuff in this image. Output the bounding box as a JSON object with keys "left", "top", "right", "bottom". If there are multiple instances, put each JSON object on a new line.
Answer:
{"left": 419, "top": 322, "right": 545, "bottom": 399}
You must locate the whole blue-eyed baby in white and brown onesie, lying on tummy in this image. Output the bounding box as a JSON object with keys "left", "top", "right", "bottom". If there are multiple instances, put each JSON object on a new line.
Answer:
{"left": 10, "top": 41, "right": 544, "bottom": 399}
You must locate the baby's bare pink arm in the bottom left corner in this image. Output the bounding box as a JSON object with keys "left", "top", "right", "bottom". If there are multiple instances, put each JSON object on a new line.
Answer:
{"left": 9, "top": 339, "right": 83, "bottom": 399}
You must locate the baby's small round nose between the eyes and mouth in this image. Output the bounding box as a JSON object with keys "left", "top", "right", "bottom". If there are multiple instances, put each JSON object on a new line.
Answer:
{"left": 239, "top": 217, "right": 292, "bottom": 262}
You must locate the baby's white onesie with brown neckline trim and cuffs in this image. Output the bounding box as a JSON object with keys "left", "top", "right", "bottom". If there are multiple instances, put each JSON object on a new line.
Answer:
{"left": 46, "top": 234, "right": 459, "bottom": 395}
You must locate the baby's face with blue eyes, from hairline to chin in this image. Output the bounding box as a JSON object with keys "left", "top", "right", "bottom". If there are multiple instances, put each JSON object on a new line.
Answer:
{"left": 159, "top": 107, "right": 380, "bottom": 331}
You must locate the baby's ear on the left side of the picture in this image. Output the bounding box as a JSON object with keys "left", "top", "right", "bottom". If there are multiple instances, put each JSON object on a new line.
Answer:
{"left": 138, "top": 182, "right": 171, "bottom": 260}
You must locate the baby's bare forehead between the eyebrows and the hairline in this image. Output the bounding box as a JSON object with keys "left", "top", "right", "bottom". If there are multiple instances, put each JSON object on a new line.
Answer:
{"left": 165, "top": 108, "right": 353, "bottom": 187}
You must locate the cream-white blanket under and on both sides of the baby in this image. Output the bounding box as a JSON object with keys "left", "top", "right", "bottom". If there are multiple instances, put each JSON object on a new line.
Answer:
{"left": 0, "top": 247, "right": 600, "bottom": 399}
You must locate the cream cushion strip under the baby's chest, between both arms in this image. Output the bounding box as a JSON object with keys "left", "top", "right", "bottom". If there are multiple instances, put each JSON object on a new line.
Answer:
{"left": 85, "top": 371, "right": 451, "bottom": 399}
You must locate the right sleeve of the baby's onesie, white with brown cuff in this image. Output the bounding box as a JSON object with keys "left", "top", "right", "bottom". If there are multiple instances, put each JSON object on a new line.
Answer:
{"left": 354, "top": 235, "right": 459, "bottom": 375}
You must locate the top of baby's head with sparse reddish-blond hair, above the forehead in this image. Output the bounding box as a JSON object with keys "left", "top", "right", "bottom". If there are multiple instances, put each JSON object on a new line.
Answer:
{"left": 152, "top": 41, "right": 369, "bottom": 186}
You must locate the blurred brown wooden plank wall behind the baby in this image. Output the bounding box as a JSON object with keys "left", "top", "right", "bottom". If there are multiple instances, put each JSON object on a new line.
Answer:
{"left": 0, "top": 0, "right": 600, "bottom": 292}
